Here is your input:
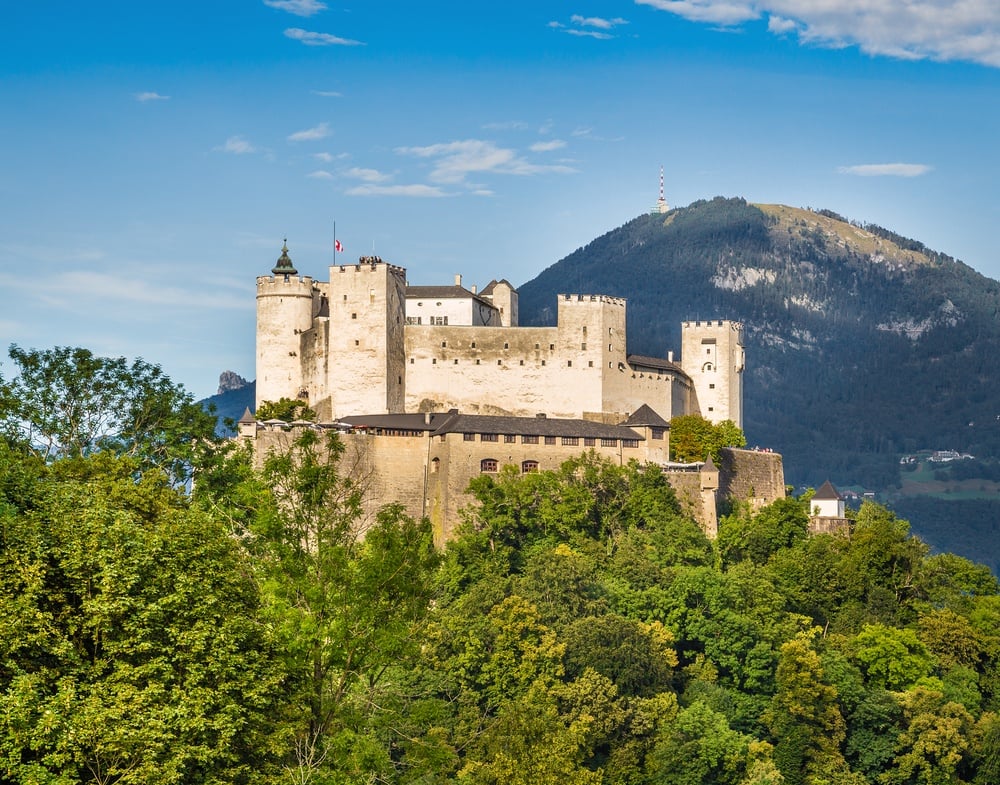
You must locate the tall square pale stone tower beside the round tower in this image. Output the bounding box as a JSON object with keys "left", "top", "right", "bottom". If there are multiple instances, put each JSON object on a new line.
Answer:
{"left": 326, "top": 256, "right": 406, "bottom": 417}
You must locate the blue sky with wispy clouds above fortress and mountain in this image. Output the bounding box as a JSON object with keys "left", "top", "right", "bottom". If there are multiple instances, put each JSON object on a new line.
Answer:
{"left": 0, "top": 0, "right": 1000, "bottom": 397}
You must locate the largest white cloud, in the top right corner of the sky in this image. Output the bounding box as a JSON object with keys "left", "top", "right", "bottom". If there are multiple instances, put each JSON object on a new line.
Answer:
{"left": 635, "top": 0, "right": 1000, "bottom": 68}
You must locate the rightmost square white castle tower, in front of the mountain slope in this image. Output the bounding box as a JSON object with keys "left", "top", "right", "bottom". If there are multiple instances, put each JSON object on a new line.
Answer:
{"left": 681, "top": 319, "right": 744, "bottom": 428}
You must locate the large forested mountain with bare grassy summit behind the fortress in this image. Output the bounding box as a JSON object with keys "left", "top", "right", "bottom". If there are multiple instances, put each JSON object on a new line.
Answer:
{"left": 519, "top": 197, "right": 1000, "bottom": 490}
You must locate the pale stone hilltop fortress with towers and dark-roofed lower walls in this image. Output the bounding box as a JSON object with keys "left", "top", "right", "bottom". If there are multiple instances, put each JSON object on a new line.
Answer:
{"left": 240, "top": 245, "right": 784, "bottom": 541}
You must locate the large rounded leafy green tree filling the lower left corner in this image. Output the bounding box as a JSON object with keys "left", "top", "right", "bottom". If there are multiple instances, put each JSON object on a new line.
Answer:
{"left": 0, "top": 453, "right": 280, "bottom": 785}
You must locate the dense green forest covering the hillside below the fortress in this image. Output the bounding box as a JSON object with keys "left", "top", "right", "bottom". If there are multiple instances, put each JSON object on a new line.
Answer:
{"left": 0, "top": 350, "right": 1000, "bottom": 785}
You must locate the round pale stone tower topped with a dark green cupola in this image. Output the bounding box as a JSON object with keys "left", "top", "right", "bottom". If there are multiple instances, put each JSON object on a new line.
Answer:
{"left": 255, "top": 241, "right": 314, "bottom": 407}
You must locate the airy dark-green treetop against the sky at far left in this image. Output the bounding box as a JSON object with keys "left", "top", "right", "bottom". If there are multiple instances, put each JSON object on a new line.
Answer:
{"left": 0, "top": 345, "right": 216, "bottom": 481}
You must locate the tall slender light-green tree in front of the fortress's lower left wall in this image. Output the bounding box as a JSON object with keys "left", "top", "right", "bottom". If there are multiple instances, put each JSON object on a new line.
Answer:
{"left": 248, "top": 430, "right": 438, "bottom": 783}
